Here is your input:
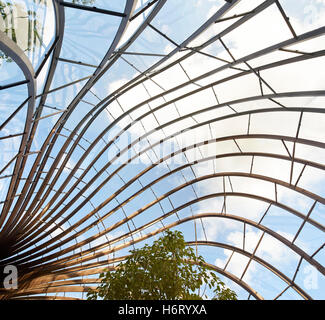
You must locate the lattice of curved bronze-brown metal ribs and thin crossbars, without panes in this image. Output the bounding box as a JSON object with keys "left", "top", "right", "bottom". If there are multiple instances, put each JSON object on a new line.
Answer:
{"left": 0, "top": 0, "right": 325, "bottom": 300}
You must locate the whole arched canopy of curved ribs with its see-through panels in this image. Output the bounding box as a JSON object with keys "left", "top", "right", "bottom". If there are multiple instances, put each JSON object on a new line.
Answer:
{"left": 0, "top": 0, "right": 325, "bottom": 300}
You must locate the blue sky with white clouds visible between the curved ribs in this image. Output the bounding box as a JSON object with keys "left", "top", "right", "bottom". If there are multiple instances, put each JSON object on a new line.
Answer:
{"left": 0, "top": 0, "right": 325, "bottom": 299}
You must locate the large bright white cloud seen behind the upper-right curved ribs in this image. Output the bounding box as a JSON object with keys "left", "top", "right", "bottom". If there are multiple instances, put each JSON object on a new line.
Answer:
{"left": 85, "top": 1, "right": 325, "bottom": 252}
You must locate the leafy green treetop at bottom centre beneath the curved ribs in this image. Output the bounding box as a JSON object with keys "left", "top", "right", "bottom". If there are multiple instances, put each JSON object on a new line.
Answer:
{"left": 87, "top": 231, "right": 237, "bottom": 300}
